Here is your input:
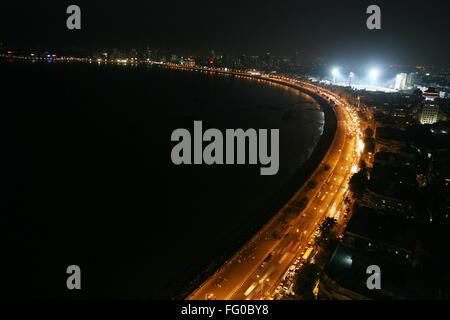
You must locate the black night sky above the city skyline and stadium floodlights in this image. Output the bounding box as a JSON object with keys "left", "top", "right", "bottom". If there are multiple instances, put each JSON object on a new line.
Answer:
{"left": 0, "top": 0, "right": 450, "bottom": 67}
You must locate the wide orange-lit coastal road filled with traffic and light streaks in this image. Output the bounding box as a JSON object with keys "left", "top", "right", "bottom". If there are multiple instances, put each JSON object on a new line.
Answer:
{"left": 187, "top": 75, "right": 359, "bottom": 300}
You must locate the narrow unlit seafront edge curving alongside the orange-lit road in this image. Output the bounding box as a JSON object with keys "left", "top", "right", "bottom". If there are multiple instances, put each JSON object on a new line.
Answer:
{"left": 172, "top": 68, "right": 337, "bottom": 299}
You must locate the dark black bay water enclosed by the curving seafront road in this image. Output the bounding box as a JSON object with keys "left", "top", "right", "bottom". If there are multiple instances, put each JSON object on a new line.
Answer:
{"left": 0, "top": 62, "right": 323, "bottom": 299}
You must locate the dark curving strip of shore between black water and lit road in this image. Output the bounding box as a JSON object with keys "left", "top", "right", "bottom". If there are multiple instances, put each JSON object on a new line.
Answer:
{"left": 1, "top": 58, "right": 336, "bottom": 299}
